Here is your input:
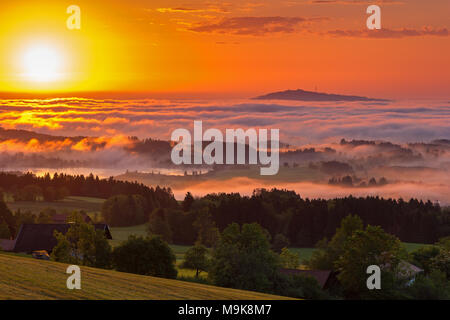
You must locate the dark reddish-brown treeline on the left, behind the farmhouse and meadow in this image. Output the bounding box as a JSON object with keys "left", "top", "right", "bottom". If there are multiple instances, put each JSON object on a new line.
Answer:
{"left": 0, "top": 173, "right": 178, "bottom": 238}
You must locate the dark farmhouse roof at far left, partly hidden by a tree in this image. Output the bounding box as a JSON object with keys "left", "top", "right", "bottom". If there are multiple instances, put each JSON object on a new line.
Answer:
{"left": 13, "top": 224, "right": 112, "bottom": 252}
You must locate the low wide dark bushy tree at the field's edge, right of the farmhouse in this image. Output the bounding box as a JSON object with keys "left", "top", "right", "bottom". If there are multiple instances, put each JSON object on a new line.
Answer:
{"left": 113, "top": 236, "right": 177, "bottom": 279}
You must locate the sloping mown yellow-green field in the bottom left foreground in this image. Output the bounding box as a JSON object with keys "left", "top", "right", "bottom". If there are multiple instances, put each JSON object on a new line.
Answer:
{"left": 0, "top": 253, "right": 292, "bottom": 300}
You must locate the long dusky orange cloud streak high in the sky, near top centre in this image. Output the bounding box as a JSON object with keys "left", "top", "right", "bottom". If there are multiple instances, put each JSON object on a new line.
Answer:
{"left": 189, "top": 16, "right": 327, "bottom": 36}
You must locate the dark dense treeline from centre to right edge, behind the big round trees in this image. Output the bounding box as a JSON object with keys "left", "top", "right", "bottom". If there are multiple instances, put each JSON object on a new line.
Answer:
{"left": 154, "top": 189, "right": 450, "bottom": 247}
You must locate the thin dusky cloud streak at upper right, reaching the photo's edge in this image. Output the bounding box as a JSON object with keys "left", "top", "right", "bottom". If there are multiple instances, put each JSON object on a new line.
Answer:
{"left": 326, "top": 27, "right": 449, "bottom": 39}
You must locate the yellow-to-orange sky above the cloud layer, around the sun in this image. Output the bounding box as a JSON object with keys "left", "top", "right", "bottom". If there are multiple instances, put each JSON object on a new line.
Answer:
{"left": 0, "top": 0, "right": 450, "bottom": 98}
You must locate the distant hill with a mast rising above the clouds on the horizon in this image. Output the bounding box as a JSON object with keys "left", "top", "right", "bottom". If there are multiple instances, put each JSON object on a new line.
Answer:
{"left": 253, "top": 89, "right": 389, "bottom": 101}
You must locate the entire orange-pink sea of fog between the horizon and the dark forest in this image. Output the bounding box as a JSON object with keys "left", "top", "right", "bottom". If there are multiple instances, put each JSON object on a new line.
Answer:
{"left": 0, "top": 98, "right": 450, "bottom": 203}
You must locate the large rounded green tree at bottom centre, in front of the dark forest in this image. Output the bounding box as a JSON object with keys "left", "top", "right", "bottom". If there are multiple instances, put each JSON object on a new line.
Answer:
{"left": 208, "top": 223, "right": 279, "bottom": 291}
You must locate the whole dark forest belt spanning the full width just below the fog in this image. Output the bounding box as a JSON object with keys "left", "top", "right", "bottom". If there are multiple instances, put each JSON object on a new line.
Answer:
{"left": 0, "top": 173, "right": 450, "bottom": 247}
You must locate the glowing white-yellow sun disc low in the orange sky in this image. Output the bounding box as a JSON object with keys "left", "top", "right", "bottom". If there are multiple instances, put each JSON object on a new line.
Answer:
{"left": 22, "top": 46, "right": 63, "bottom": 82}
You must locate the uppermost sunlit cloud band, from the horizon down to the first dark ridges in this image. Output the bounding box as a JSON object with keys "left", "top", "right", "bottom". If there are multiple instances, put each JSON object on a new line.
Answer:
{"left": 0, "top": 98, "right": 450, "bottom": 145}
